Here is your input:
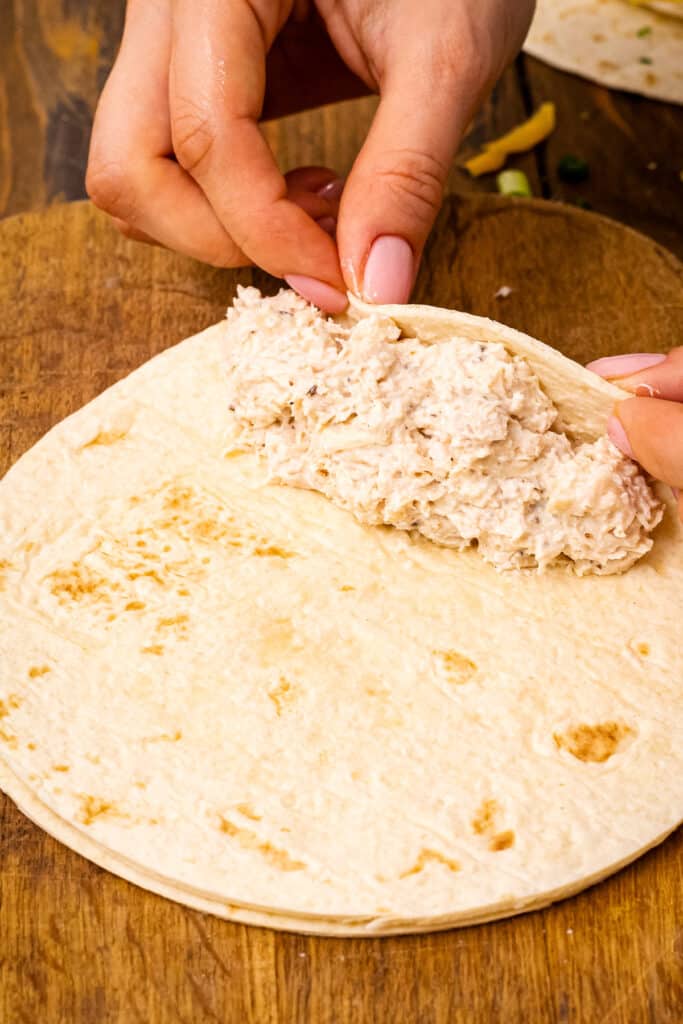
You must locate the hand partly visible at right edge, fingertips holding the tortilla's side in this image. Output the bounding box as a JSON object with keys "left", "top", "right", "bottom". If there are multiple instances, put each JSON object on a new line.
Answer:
{"left": 588, "top": 348, "right": 683, "bottom": 520}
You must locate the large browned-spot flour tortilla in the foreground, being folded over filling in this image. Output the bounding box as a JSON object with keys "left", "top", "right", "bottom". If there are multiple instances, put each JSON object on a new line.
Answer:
{"left": 0, "top": 299, "right": 683, "bottom": 935}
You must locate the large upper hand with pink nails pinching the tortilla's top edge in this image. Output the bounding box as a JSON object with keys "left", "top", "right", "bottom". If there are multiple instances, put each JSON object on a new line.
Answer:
{"left": 86, "top": 0, "right": 533, "bottom": 312}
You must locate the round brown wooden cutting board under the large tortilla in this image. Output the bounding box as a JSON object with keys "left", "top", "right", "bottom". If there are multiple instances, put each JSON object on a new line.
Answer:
{"left": 0, "top": 196, "right": 683, "bottom": 1024}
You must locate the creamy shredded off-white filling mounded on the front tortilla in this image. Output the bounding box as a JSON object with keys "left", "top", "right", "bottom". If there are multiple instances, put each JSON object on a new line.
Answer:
{"left": 226, "top": 288, "right": 663, "bottom": 573}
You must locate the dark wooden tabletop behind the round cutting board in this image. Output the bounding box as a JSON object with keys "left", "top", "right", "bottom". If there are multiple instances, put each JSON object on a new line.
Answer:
{"left": 0, "top": 0, "right": 683, "bottom": 256}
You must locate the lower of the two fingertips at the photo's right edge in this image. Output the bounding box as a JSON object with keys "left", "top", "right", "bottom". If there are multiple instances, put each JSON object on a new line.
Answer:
{"left": 607, "top": 398, "right": 683, "bottom": 488}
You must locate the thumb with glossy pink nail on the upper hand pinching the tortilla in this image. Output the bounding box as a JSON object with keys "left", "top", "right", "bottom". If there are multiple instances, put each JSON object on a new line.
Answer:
{"left": 337, "top": 52, "right": 485, "bottom": 303}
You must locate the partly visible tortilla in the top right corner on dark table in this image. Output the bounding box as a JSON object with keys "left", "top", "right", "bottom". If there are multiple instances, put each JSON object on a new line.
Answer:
{"left": 524, "top": 0, "right": 683, "bottom": 103}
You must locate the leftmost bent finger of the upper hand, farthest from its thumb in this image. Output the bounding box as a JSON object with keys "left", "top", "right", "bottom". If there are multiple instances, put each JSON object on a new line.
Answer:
{"left": 86, "top": 0, "right": 249, "bottom": 266}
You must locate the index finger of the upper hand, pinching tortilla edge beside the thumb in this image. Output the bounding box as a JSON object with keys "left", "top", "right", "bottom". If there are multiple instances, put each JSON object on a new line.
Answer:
{"left": 170, "top": 0, "right": 346, "bottom": 311}
